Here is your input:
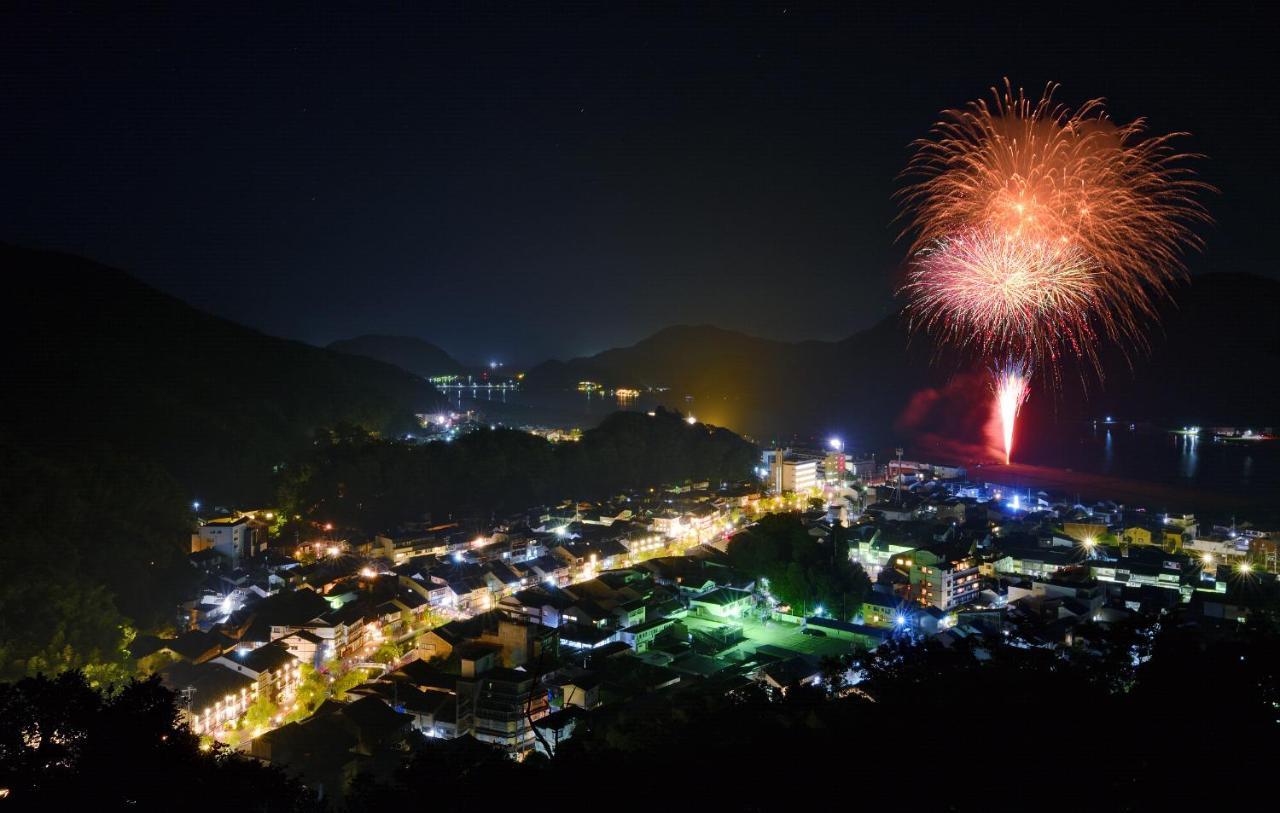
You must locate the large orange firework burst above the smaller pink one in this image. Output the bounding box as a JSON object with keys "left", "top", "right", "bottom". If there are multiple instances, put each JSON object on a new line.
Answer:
{"left": 900, "top": 79, "right": 1211, "bottom": 348}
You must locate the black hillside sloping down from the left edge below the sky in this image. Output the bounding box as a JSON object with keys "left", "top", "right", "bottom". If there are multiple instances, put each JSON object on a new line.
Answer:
{"left": 0, "top": 246, "right": 439, "bottom": 503}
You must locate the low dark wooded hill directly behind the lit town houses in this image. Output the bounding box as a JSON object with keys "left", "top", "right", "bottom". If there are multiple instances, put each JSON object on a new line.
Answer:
{"left": 279, "top": 411, "right": 756, "bottom": 531}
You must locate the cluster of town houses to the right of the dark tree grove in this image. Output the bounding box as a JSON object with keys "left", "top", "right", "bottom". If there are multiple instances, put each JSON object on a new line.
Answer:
{"left": 844, "top": 479, "right": 1280, "bottom": 647}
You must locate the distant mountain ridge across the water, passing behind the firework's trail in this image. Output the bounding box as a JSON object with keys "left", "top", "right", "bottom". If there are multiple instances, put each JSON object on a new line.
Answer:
{"left": 527, "top": 274, "right": 1280, "bottom": 448}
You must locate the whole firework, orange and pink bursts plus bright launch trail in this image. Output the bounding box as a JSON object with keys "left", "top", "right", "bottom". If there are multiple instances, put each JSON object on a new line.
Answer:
{"left": 899, "top": 79, "right": 1212, "bottom": 462}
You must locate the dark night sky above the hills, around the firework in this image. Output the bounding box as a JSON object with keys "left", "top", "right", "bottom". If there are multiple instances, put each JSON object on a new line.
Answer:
{"left": 0, "top": 3, "right": 1280, "bottom": 364}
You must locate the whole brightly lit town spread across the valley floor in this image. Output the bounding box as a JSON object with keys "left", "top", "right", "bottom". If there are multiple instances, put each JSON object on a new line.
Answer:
{"left": 131, "top": 439, "right": 1280, "bottom": 787}
